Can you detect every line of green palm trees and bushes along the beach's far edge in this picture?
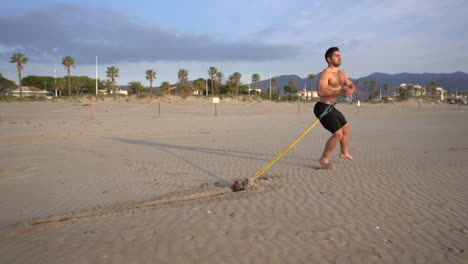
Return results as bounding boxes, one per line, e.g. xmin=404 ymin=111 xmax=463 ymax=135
xmin=10 ymin=53 xmax=446 ymax=101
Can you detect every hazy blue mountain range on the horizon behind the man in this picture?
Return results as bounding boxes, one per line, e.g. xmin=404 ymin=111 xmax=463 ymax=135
xmin=254 ymin=71 xmax=468 ymax=92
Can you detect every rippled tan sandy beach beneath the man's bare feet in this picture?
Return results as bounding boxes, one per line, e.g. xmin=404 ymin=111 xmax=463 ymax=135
xmin=0 ymin=97 xmax=468 ymax=263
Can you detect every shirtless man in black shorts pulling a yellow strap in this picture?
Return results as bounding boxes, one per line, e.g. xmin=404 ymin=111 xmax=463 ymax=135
xmin=314 ymin=47 xmax=356 ymax=166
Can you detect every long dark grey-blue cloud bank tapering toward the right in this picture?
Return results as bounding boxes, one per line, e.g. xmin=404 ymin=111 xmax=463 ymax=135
xmin=0 ymin=4 xmax=296 ymax=63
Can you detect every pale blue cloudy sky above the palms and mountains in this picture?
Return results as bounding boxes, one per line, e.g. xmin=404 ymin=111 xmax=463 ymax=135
xmin=0 ymin=0 xmax=468 ymax=85
